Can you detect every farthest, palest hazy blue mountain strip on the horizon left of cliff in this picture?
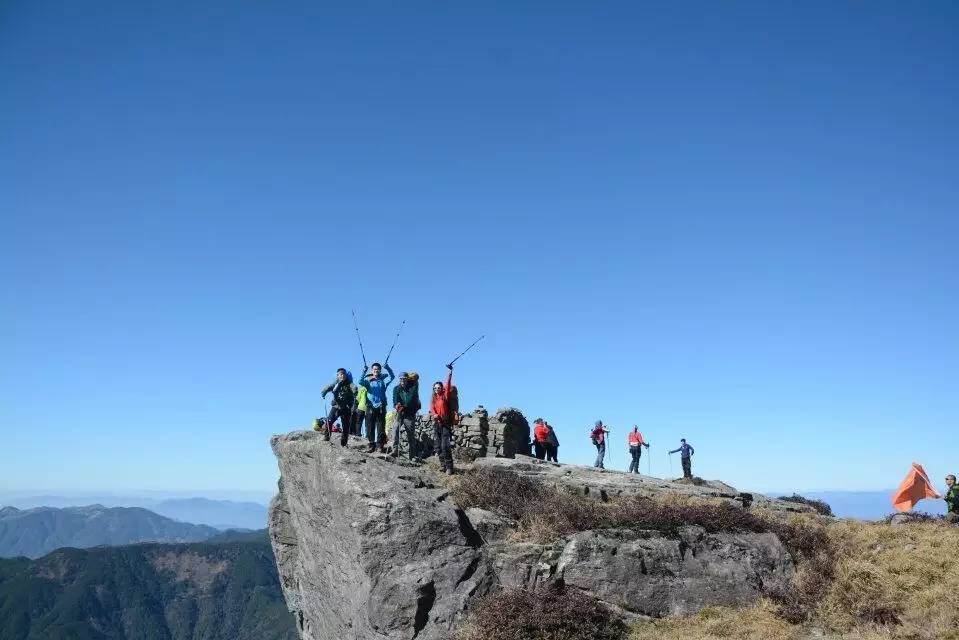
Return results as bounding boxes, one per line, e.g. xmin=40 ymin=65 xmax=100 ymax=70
xmin=0 ymin=494 xmax=267 ymax=529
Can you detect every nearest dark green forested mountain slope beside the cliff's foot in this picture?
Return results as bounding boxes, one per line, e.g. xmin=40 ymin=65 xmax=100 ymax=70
xmin=0 ymin=531 xmax=298 ymax=640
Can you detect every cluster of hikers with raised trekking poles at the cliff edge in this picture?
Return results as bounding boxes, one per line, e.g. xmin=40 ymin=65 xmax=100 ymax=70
xmin=314 ymin=362 xmax=459 ymax=475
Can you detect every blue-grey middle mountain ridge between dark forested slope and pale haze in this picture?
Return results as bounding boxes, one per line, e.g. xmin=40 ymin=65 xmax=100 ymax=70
xmin=0 ymin=505 xmax=220 ymax=558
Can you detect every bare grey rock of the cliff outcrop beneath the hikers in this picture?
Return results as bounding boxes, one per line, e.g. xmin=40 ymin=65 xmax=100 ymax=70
xmin=270 ymin=432 xmax=793 ymax=640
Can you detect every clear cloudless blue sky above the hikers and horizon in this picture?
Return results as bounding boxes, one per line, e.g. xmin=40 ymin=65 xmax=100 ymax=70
xmin=0 ymin=0 xmax=959 ymax=491
